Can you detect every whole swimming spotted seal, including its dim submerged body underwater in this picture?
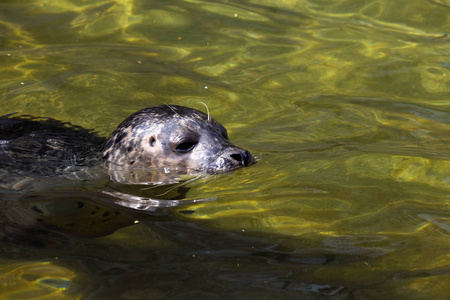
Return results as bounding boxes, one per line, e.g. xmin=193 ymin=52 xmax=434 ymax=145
xmin=0 ymin=105 xmax=255 ymax=247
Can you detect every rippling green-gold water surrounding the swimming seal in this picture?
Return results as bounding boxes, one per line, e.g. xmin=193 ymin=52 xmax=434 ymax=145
xmin=0 ymin=0 xmax=450 ymax=299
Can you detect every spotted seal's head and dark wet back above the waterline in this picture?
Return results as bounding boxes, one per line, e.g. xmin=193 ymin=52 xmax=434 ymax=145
xmin=0 ymin=105 xmax=256 ymax=190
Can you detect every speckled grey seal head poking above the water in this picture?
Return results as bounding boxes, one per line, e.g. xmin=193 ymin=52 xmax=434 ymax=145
xmin=102 ymin=105 xmax=256 ymax=174
